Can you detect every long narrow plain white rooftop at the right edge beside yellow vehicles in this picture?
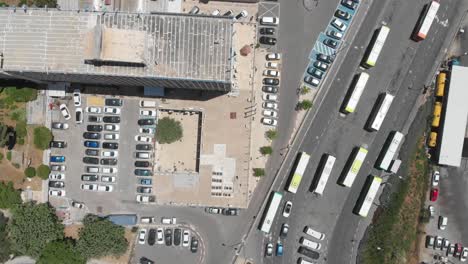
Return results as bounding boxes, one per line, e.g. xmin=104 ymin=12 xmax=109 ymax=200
xmin=439 ymin=66 xmax=468 ymax=167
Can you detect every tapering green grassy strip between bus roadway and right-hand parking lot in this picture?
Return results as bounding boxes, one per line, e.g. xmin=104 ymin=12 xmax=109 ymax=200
xmin=362 ymin=137 xmax=429 ymax=264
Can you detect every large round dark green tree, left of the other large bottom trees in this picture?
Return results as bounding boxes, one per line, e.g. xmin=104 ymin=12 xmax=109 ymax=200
xmin=8 ymin=203 xmax=63 ymax=258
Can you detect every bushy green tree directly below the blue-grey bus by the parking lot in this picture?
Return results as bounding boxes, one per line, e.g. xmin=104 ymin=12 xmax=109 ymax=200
xmin=76 ymin=215 xmax=128 ymax=259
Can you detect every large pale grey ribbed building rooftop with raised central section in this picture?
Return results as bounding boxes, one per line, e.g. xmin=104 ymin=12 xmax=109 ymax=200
xmin=0 ymin=9 xmax=232 ymax=82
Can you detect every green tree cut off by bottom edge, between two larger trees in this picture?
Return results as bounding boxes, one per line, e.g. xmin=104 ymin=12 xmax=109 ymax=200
xmin=37 ymin=239 xmax=86 ymax=264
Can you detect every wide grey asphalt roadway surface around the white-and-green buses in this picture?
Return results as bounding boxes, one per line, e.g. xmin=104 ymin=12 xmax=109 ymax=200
xmin=236 ymin=1 xmax=465 ymax=264
